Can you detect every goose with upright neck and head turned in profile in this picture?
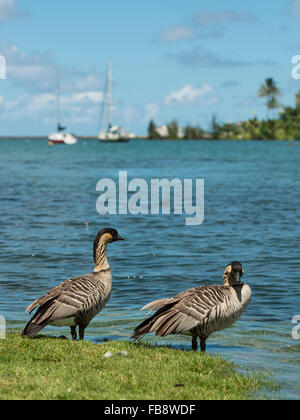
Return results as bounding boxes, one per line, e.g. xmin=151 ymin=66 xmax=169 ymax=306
xmin=22 ymin=228 xmax=123 ymax=340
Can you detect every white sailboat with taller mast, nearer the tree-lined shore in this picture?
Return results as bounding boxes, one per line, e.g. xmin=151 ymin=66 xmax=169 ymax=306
xmin=98 ymin=61 xmax=134 ymax=143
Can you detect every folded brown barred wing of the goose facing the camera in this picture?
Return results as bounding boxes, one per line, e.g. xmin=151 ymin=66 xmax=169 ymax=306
xmin=132 ymin=286 xmax=226 ymax=338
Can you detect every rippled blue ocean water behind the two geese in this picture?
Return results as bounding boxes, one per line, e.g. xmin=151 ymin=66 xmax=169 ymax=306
xmin=0 ymin=140 xmax=300 ymax=399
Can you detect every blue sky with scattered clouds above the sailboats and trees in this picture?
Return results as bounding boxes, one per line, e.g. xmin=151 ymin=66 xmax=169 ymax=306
xmin=0 ymin=0 xmax=300 ymax=136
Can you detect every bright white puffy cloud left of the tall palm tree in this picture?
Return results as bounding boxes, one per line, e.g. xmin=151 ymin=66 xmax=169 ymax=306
xmin=164 ymin=83 xmax=213 ymax=106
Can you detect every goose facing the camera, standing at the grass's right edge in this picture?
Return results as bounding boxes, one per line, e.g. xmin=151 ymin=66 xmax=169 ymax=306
xmin=132 ymin=261 xmax=251 ymax=352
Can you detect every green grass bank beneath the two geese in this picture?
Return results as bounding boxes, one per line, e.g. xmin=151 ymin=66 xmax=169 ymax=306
xmin=0 ymin=334 xmax=264 ymax=400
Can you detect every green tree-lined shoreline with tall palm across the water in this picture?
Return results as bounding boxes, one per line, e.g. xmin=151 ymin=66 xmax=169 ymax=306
xmin=148 ymin=78 xmax=300 ymax=140
